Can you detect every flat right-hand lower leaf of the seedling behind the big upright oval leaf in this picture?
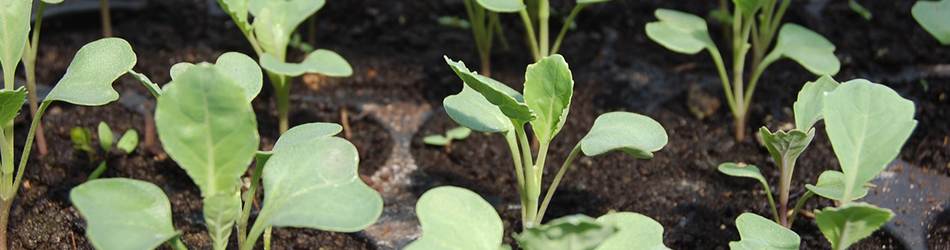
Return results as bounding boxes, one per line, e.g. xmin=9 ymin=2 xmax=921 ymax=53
xmin=261 ymin=49 xmax=353 ymax=77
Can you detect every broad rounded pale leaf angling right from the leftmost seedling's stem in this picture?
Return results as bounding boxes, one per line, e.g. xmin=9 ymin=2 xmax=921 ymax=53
xmin=44 ymin=38 xmax=138 ymax=106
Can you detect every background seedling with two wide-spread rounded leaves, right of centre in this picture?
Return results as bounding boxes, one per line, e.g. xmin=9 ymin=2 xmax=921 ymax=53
xmin=646 ymin=0 xmax=841 ymax=141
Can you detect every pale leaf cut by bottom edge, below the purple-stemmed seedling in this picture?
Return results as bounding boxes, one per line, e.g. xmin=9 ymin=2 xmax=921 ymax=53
xmin=729 ymin=213 xmax=801 ymax=250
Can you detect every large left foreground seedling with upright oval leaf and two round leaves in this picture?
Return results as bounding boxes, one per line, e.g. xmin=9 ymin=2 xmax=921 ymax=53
xmin=70 ymin=56 xmax=382 ymax=250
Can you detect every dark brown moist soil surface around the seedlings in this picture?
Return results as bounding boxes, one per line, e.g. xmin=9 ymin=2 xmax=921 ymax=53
xmin=9 ymin=0 xmax=950 ymax=249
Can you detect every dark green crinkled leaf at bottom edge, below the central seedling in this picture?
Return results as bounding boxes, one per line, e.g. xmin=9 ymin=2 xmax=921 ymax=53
xmin=515 ymin=214 xmax=617 ymax=250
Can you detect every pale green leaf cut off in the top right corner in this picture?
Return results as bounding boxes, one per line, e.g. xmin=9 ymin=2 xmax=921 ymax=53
xmin=910 ymin=0 xmax=950 ymax=45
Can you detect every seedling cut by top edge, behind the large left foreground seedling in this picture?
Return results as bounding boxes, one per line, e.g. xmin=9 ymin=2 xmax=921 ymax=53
xmin=217 ymin=0 xmax=353 ymax=134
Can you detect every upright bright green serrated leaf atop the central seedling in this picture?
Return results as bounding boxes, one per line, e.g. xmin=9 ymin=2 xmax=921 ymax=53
xmin=524 ymin=55 xmax=574 ymax=143
